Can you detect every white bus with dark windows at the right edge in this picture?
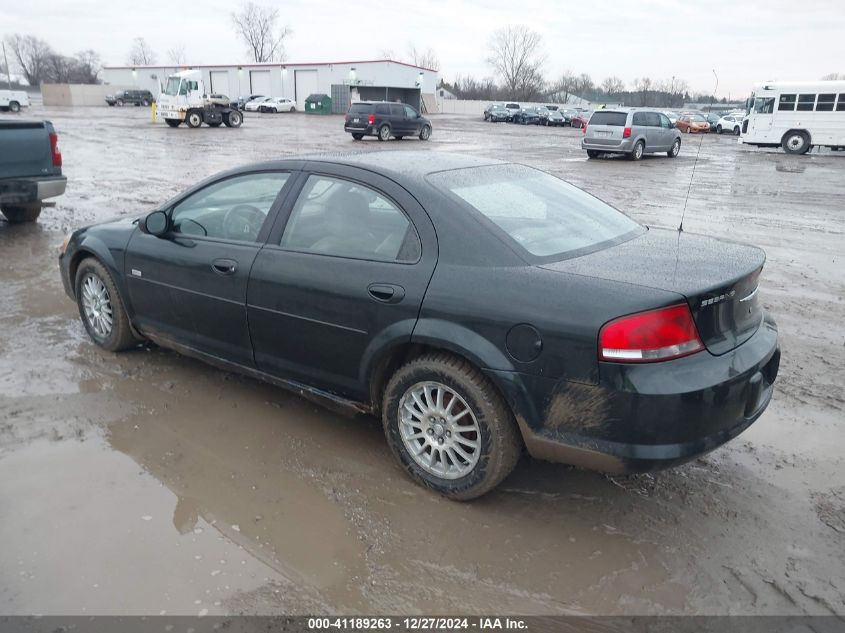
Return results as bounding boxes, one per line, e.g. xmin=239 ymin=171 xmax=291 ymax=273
xmin=739 ymin=81 xmax=845 ymax=154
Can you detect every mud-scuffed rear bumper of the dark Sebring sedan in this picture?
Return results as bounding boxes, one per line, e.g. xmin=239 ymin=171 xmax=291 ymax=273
xmin=487 ymin=319 xmax=780 ymax=473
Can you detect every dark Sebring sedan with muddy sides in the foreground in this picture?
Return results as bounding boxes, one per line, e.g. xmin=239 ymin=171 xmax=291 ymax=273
xmin=60 ymin=151 xmax=780 ymax=499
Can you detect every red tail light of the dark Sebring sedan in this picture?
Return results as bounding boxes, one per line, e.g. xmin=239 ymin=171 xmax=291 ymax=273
xmin=599 ymin=303 xmax=704 ymax=363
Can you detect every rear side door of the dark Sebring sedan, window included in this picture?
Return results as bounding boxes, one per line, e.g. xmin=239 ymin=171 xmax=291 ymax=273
xmin=247 ymin=163 xmax=437 ymax=400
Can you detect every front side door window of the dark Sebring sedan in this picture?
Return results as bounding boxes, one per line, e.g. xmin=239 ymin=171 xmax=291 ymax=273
xmin=171 ymin=172 xmax=290 ymax=242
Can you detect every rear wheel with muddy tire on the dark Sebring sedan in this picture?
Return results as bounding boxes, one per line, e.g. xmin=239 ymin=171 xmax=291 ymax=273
xmin=382 ymin=353 xmax=522 ymax=501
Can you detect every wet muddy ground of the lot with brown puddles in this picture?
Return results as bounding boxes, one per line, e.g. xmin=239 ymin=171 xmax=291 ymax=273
xmin=0 ymin=107 xmax=845 ymax=614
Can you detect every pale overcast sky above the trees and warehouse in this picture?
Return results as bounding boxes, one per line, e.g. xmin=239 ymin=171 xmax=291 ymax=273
xmin=0 ymin=0 xmax=845 ymax=97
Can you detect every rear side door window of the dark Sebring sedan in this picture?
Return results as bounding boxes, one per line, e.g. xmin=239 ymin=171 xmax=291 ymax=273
xmin=281 ymin=175 xmax=421 ymax=263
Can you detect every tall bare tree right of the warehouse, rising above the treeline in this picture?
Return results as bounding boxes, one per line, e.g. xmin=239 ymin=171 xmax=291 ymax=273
xmin=487 ymin=24 xmax=545 ymax=100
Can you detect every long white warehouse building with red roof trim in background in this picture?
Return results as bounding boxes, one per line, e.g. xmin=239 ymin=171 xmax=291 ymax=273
xmin=101 ymin=59 xmax=439 ymax=113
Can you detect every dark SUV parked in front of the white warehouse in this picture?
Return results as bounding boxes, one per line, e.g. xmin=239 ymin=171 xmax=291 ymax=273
xmin=343 ymin=101 xmax=431 ymax=141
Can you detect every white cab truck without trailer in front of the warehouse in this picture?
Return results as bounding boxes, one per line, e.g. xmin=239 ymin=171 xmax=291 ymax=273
xmin=156 ymin=70 xmax=244 ymax=127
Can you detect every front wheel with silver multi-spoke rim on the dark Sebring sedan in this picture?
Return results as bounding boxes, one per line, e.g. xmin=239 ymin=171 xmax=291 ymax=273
xmin=74 ymin=257 xmax=141 ymax=352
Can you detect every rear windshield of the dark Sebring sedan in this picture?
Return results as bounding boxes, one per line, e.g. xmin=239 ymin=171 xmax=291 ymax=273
xmin=428 ymin=165 xmax=646 ymax=262
